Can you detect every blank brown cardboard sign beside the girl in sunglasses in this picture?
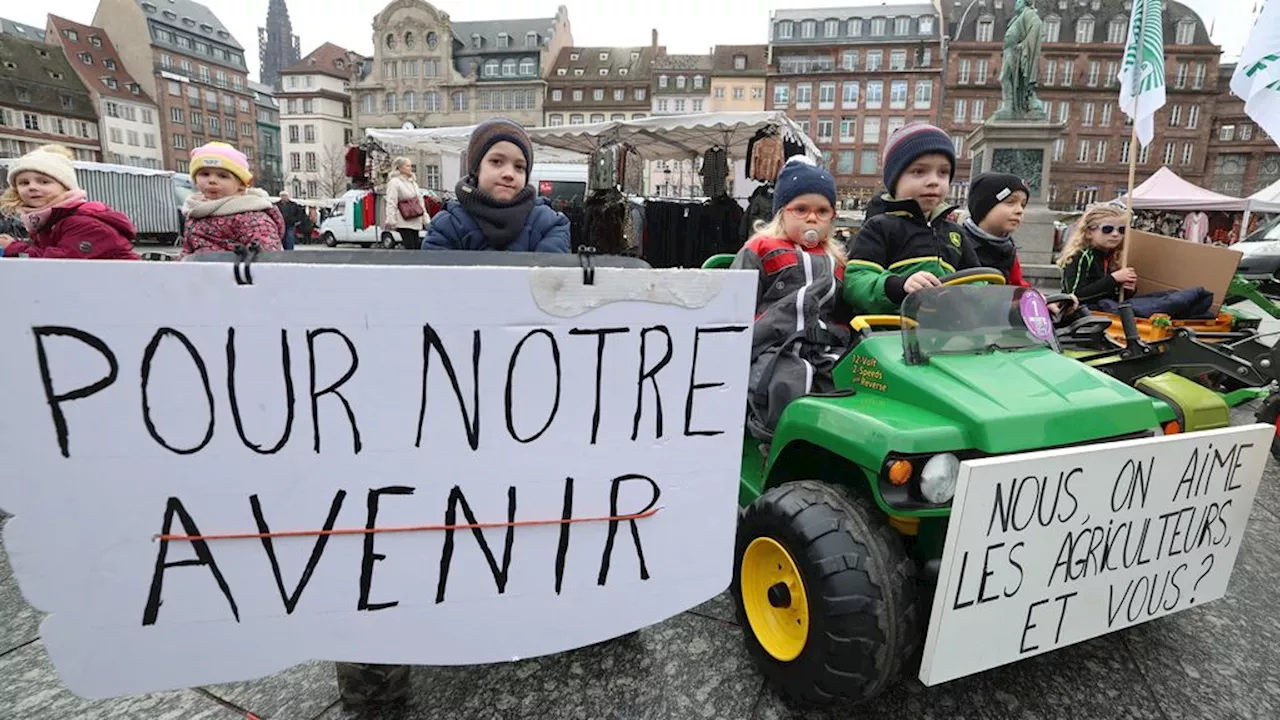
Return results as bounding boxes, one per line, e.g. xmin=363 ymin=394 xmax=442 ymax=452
xmin=1129 ymin=229 xmax=1243 ymax=313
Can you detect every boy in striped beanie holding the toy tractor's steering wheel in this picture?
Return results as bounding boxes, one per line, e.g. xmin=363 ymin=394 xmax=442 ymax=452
xmin=846 ymin=123 xmax=979 ymax=313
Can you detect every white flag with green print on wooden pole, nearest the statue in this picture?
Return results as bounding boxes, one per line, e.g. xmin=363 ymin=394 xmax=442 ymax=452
xmin=1119 ymin=0 xmax=1165 ymax=147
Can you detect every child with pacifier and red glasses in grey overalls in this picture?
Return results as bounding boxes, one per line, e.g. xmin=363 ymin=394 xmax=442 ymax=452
xmin=732 ymin=156 xmax=852 ymax=442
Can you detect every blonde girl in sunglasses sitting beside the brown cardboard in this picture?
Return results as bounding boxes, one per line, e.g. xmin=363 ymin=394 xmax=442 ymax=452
xmin=1057 ymin=205 xmax=1138 ymax=306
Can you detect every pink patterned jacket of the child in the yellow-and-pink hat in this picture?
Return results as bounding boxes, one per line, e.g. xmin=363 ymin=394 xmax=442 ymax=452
xmin=182 ymin=187 xmax=284 ymax=258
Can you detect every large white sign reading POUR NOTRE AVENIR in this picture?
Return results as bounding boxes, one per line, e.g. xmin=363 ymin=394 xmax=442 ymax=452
xmin=0 ymin=260 xmax=756 ymax=698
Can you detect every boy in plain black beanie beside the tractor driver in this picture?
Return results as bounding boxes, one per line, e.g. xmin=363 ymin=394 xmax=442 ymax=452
xmin=961 ymin=173 xmax=1032 ymax=287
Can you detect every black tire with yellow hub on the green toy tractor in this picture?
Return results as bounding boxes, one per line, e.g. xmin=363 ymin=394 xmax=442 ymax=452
xmin=732 ymin=480 xmax=919 ymax=706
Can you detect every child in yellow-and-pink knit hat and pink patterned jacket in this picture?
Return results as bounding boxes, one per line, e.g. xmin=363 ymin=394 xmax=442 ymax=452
xmin=182 ymin=142 xmax=284 ymax=258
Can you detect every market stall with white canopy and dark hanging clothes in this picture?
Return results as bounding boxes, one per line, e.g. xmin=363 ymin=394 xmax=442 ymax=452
xmin=366 ymin=111 xmax=822 ymax=268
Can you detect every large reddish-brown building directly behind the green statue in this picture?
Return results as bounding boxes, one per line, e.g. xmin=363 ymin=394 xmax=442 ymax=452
xmin=941 ymin=0 xmax=1222 ymax=209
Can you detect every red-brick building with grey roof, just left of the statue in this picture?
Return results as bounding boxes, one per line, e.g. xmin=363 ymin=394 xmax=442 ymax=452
xmin=765 ymin=3 xmax=942 ymax=200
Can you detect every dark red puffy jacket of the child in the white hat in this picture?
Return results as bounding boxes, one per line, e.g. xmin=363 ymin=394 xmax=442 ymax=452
xmin=0 ymin=201 xmax=140 ymax=260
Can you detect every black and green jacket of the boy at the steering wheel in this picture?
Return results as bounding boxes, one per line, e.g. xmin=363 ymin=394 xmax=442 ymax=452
xmin=845 ymin=195 xmax=979 ymax=314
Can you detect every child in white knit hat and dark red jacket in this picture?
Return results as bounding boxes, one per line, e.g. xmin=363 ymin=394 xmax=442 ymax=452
xmin=0 ymin=145 xmax=138 ymax=260
